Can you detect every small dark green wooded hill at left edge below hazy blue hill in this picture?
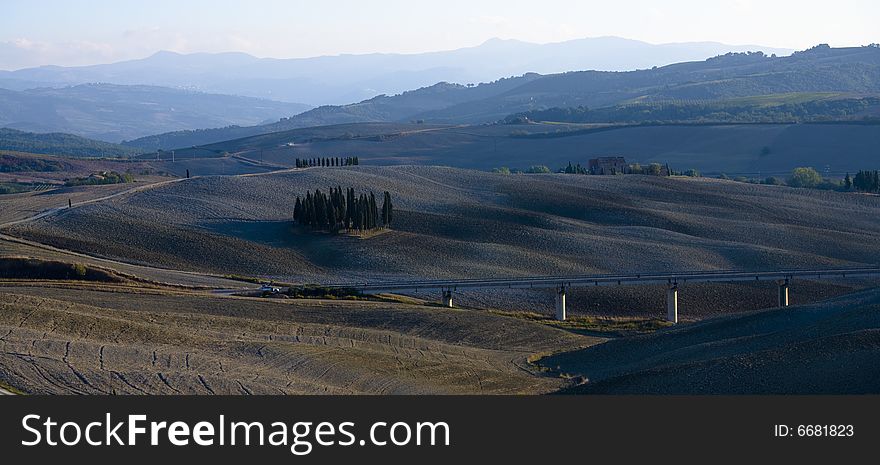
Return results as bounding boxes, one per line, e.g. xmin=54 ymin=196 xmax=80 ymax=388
xmin=0 ymin=128 xmax=141 ymax=158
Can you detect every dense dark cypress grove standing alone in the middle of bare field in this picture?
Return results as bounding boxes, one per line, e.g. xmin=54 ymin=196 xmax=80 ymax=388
xmin=293 ymin=187 xmax=394 ymax=233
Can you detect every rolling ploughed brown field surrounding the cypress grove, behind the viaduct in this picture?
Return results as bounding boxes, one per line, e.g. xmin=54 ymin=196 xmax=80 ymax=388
xmin=4 ymin=166 xmax=880 ymax=319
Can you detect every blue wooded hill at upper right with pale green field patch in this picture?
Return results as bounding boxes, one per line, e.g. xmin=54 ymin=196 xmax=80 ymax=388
xmin=417 ymin=46 xmax=880 ymax=123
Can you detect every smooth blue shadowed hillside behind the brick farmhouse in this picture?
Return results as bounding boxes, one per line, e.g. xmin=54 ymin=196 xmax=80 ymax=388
xmin=155 ymin=123 xmax=880 ymax=177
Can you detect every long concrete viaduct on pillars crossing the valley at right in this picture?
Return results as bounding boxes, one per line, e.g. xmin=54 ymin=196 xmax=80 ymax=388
xmin=324 ymin=266 xmax=880 ymax=323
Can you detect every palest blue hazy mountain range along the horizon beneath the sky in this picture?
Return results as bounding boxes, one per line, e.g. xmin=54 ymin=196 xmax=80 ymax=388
xmin=0 ymin=37 xmax=792 ymax=106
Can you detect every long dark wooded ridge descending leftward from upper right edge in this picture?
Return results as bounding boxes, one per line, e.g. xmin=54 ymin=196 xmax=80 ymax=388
xmin=127 ymin=45 xmax=880 ymax=150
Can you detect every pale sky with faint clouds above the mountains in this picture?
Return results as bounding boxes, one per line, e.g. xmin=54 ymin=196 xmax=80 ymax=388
xmin=0 ymin=0 xmax=880 ymax=70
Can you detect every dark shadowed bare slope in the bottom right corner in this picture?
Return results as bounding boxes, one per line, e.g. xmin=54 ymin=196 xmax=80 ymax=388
xmin=539 ymin=289 xmax=880 ymax=394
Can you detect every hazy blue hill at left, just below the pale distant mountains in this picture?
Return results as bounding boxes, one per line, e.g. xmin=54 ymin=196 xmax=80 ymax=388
xmin=0 ymin=84 xmax=309 ymax=142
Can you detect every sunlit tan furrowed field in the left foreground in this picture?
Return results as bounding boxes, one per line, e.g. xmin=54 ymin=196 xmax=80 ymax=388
xmin=0 ymin=283 xmax=601 ymax=394
